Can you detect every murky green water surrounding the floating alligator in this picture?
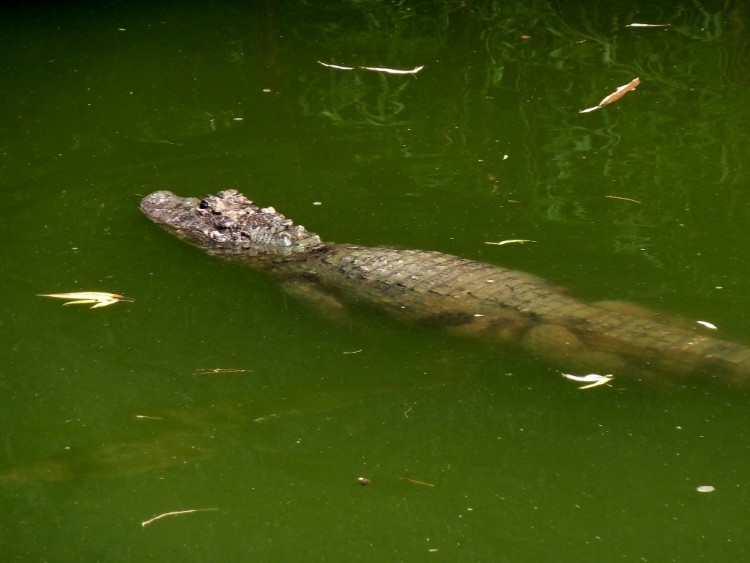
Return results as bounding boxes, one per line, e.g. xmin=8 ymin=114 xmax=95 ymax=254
xmin=0 ymin=0 xmax=750 ymax=561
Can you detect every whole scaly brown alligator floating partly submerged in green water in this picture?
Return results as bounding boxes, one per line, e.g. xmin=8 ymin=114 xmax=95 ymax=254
xmin=140 ymin=189 xmax=750 ymax=387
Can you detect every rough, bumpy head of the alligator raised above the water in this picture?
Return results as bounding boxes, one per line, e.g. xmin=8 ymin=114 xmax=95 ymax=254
xmin=141 ymin=190 xmax=323 ymax=256
